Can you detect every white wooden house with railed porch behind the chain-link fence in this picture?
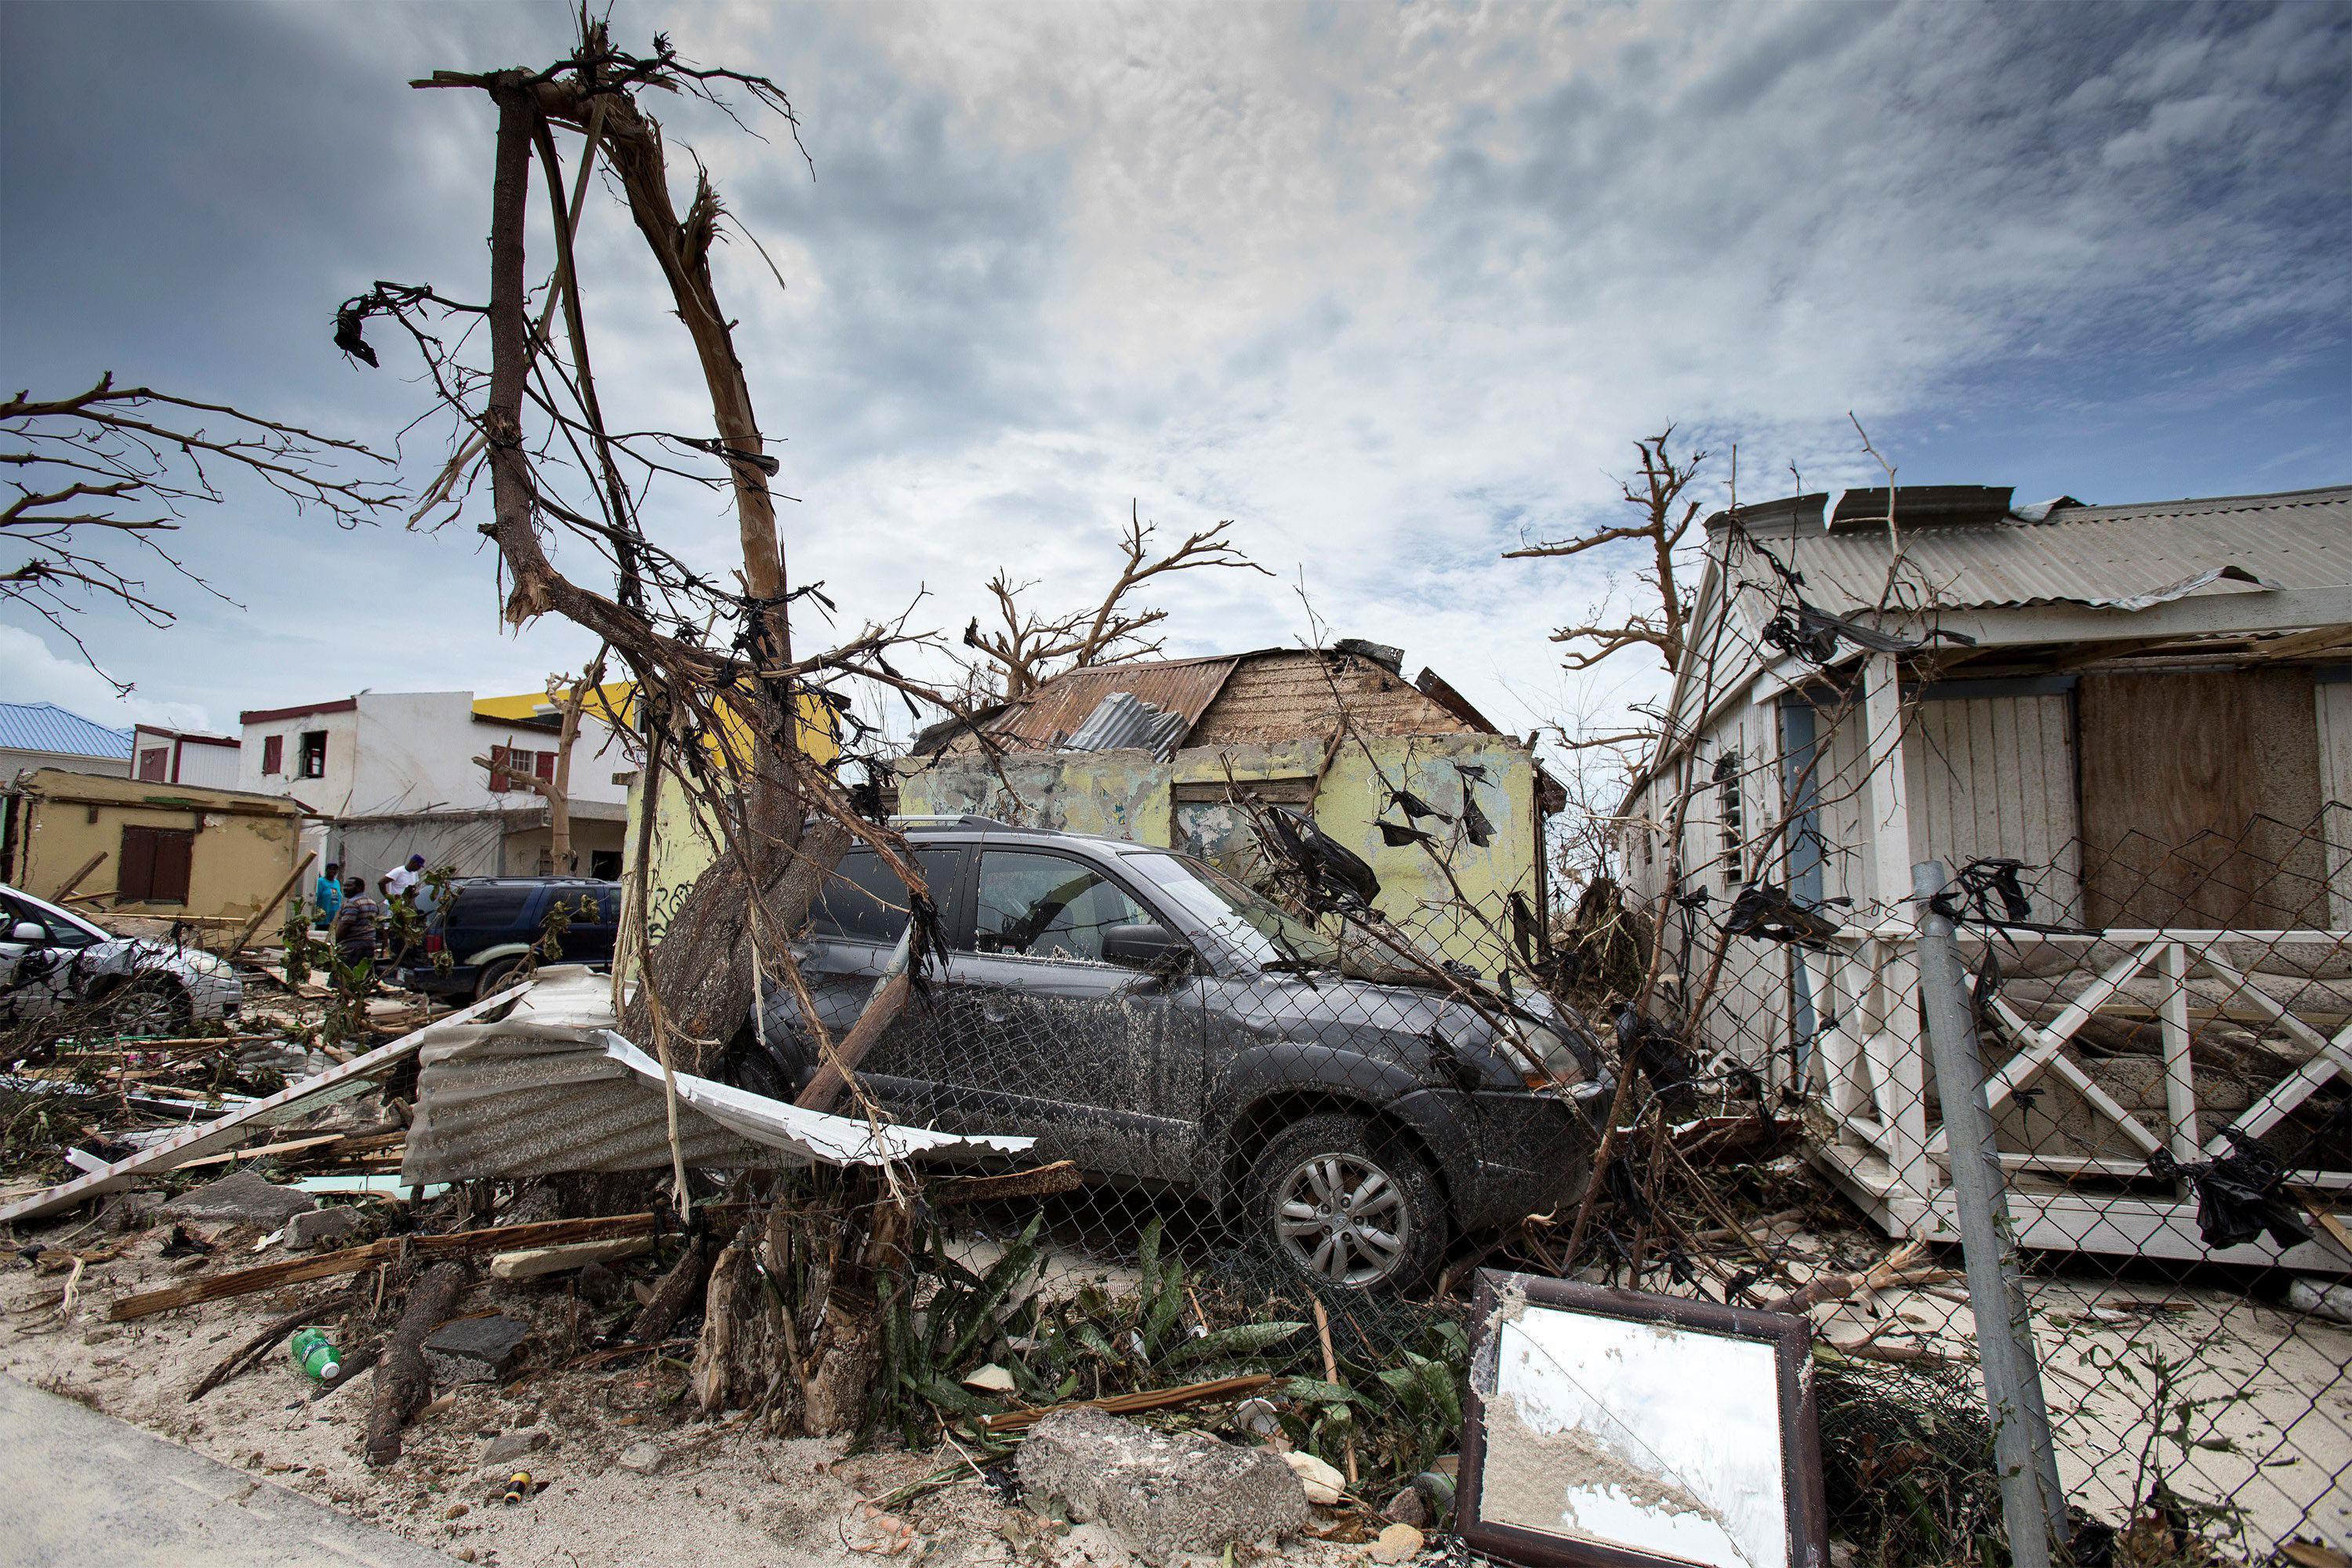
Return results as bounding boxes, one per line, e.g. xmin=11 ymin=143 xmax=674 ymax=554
xmin=1621 ymin=487 xmax=2352 ymax=1267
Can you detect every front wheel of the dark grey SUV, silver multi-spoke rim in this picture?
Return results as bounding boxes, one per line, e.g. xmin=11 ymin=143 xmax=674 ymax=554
xmin=1251 ymin=1114 xmax=1446 ymax=1293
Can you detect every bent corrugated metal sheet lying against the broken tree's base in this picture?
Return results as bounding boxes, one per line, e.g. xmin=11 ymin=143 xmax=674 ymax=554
xmin=400 ymin=964 xmax=1033 ymax=1182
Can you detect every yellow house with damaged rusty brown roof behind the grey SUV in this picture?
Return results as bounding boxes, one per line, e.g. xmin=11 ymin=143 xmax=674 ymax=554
xmin=898 ymin=640 xmax=1564 ymax=973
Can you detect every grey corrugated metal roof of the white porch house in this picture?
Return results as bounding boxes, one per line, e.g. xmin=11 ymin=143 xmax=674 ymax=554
xmin=1738 ymin=487 xmax=2352 ymax=614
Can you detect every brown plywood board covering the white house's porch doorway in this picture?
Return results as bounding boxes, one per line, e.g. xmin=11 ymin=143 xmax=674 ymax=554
xmin=2074 ymin=670 xmax=2326 ymax=928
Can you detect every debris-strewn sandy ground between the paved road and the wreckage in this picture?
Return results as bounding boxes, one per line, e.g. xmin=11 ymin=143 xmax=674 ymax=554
xmin=0 ymin=1227 xmax=1364 ymax=1568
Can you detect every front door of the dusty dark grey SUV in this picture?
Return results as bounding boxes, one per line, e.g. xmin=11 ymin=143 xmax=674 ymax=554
xmin=941 ymin=841 xmax=1202 ymax=1182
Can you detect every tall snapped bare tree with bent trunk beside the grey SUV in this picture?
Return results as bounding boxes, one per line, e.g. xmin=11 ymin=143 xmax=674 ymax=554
xmin=336 ymin=21 xmax=964 ymax=1105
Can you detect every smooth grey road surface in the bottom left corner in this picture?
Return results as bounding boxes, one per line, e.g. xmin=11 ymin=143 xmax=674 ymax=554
xmin=0 ymin=1375 xmax=452 ymax=1568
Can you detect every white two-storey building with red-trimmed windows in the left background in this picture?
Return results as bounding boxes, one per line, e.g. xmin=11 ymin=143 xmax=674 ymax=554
xmin=238 ymin=691 xmax=630 ymax=881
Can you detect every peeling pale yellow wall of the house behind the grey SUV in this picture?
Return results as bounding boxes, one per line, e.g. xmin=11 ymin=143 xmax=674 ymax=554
xmin=898 ymin=734 xmax=1543 ymax=973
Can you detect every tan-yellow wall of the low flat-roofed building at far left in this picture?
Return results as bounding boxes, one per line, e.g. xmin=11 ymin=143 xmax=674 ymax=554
xmin=9 ymin=769 xmax=308 ymax=921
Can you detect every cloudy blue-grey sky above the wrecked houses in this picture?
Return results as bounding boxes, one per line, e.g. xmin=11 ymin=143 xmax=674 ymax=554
xmin=0 ymin=0 xmax=2352 ymax=747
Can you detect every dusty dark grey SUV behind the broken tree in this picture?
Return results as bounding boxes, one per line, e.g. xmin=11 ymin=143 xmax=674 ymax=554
xmin=734 ymin=818 xmax=1609 ymax=1290
